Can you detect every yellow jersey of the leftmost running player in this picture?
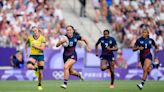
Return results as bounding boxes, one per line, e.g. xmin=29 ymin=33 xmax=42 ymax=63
xmin=28 ymin=35 xmax=45 ymax=55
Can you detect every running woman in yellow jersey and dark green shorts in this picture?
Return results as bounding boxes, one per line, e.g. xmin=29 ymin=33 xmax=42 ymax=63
xmin=25 ymin=27 xmax=46 ymax=90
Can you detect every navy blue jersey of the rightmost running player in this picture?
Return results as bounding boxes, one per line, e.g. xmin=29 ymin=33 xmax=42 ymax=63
xmin=135 ymin=37 xmax=155 ymax=59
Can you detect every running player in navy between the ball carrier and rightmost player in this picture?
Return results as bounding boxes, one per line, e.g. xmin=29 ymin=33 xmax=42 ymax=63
xmin=95 ymin=30 xmax=118 ymax=88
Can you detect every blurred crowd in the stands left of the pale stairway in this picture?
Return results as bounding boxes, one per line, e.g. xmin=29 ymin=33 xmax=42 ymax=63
xmin=0 ymin=0 xmax=66 ymax=50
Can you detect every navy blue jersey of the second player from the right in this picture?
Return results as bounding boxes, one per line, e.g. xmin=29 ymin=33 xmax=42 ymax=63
xmin=96 ymin=37 xmax=117 ymax=56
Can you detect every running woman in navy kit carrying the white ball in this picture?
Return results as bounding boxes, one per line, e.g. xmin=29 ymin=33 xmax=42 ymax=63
xmin=56 ymin=25 xmax=90 ymax=89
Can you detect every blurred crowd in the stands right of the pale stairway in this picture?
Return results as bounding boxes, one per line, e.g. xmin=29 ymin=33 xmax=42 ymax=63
xmin=107 ymin=0 xmax=164 ymax=50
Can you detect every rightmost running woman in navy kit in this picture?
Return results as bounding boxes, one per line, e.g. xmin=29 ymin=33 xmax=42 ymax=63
xmin=133 ymin=29 xmax=158 ymax=90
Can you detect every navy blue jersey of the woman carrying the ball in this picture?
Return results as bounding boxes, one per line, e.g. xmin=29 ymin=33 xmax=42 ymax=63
xmin=63 ymin=35 xmax=81 ymax=57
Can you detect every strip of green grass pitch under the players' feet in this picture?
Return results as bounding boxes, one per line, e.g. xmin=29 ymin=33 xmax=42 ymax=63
xmin=0 ymin=81 xmax=164 ymax=92
